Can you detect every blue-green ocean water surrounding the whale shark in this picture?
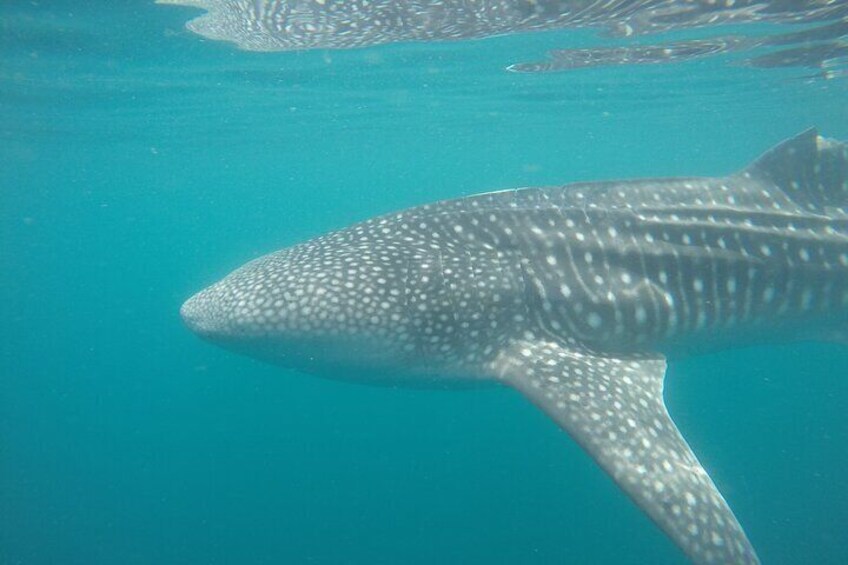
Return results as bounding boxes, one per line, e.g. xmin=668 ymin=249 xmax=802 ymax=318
xmin=0 ymin=1 xmax=848 ymax=565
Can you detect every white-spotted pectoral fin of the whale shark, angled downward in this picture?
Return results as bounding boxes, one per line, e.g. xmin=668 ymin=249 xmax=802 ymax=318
xmin=489 ymin=341 xmax=759 ymax=563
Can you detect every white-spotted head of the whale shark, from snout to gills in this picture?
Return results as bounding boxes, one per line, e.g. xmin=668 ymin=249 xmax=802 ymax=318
xmin=180 ymin=206 xmax=527 ymax=388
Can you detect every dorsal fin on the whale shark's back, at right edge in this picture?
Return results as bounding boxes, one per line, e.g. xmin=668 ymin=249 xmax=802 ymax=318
xmin=743 ymin=128 xmax=848 ymax=209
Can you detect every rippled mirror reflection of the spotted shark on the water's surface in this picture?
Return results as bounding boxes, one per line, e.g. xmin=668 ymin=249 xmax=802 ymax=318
xmin=161 ymin=0 xmax=848 ymax=77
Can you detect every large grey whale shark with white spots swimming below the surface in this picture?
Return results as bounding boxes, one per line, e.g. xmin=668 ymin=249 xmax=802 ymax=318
xmin=181 ymin=129 xmax=848 ymax=563
